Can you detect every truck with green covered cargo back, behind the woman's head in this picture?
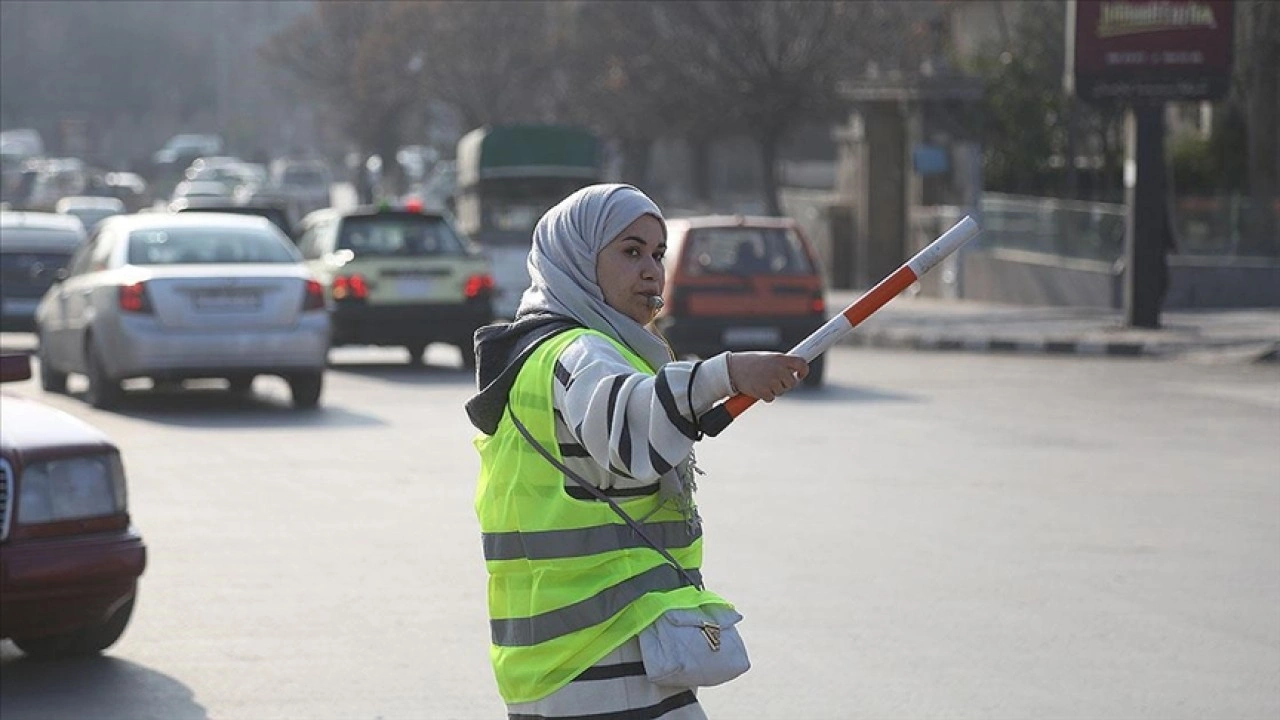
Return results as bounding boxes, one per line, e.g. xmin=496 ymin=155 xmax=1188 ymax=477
xmin=454 ymin=124 xmax=602 ymax=318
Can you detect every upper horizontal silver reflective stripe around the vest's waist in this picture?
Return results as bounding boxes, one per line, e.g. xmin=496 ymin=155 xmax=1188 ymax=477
xmin=484 ymin=520 xmax=703 ymax=560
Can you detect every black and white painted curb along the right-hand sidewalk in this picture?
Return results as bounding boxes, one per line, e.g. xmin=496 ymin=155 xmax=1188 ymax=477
xmin=844 ymin=329 xmax=1280 ymax=363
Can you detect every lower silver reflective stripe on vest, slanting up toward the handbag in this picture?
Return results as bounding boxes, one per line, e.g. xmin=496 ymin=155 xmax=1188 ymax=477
xmin=489 ymin=564 xmax=703 ymax=647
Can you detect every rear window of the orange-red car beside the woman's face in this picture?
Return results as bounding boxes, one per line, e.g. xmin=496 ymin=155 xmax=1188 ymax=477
xmin=685 ymin=228 xmax=813 ymax=275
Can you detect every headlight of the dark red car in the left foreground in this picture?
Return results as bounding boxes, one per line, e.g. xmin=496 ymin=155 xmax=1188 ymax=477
xmin=17 ymin=454 xmax=128 ymax=525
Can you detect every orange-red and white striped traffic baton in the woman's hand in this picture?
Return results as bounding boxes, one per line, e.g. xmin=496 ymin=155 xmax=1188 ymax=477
xmin=699 ymin=215 xmax=978 ymax=437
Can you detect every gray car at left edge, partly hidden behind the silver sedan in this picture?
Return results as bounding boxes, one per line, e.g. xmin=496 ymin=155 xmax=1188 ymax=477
xmin=0 ymin=211 xmax=84 ymax=332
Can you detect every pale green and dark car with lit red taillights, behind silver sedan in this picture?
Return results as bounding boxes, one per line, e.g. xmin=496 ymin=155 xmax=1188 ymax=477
xmin=298 ymin=208 xmax=494 ymax=368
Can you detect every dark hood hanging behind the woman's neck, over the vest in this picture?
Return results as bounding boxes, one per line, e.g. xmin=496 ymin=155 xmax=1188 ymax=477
xmin=466 ymin=313 xmax=582 ymax=436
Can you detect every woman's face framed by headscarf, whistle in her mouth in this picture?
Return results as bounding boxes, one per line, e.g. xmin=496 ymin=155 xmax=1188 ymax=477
xmin=595 ymin=215 xmax=667 ymax=325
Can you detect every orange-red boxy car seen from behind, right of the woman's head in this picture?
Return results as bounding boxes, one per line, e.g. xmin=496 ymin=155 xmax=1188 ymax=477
xmin=657 ymin=215 xmax=827 ymax=387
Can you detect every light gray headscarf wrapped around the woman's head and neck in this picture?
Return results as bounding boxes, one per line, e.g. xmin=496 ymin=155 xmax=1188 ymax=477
xmin=516 ymin=184 xmax=671 ymax=369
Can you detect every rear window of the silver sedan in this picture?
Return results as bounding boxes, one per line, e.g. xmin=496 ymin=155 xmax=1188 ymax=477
xmin=129 ymin=227 xmax=300 ymax=265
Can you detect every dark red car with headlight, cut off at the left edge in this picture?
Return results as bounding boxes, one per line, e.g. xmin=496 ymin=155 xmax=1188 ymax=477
xmin=0 ymin=355 xmax=147 ymax=657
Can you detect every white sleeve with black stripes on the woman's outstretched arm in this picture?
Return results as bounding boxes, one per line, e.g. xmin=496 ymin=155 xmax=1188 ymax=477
xmin=553 ymin=334 xmax=731 ymax=489
